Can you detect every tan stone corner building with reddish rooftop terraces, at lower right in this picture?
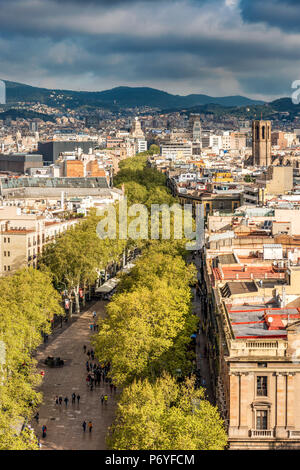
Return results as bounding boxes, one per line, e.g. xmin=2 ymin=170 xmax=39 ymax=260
xmin=205 ymin=255 xmax=300 ymax=450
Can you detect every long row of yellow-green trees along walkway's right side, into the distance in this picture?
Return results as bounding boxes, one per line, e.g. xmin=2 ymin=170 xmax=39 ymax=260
xmin=94 ymin=157 xmax=227 ymax=450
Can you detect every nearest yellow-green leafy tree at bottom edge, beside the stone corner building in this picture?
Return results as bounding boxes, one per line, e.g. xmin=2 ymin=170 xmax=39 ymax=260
xmin=107 ymin=375 xmax=227 ymax=450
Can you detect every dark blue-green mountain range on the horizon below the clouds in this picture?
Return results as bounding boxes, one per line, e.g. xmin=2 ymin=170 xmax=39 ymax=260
xmin=3 ymin=80 xmax=263 ymax=110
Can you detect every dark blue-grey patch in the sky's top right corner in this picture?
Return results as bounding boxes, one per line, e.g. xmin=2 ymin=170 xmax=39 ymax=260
xmin=240 ymin=0 xmax=300 ymax=32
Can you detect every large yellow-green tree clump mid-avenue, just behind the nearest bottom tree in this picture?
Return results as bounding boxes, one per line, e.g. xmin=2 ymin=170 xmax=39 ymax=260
xmin=95 ymin=243 xmax=197 ymax=386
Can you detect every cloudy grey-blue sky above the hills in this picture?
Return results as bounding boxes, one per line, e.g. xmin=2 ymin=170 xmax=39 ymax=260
xmin=0 ymin=0 xmax=300 ymax=100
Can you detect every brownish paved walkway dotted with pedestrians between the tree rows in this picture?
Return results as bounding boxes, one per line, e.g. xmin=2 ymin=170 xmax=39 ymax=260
xmin=32 ymin=301 xmax=117 ymax=450
